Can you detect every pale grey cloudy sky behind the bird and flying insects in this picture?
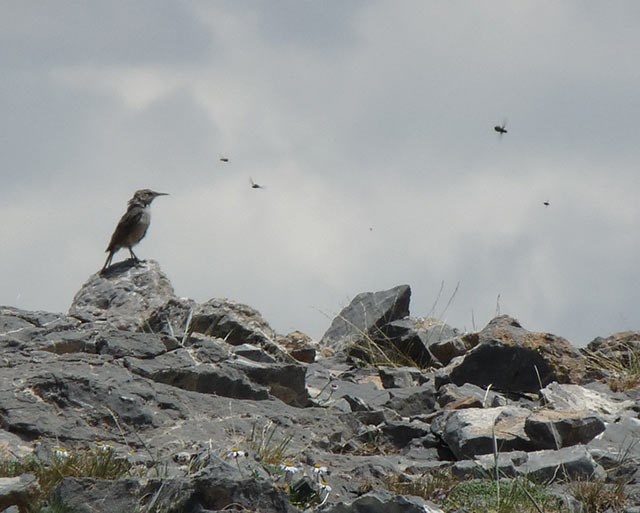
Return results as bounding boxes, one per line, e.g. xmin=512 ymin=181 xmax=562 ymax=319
xmin=0 ymin=0 xmax=640 ymax=345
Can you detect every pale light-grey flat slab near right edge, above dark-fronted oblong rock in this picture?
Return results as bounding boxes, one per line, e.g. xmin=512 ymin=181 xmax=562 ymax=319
xmin=540 ymin=383 xmax=635 ymax=422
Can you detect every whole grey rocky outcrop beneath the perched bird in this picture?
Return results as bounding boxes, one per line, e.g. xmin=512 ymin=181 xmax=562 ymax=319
xmin=0 ymin=272 xmax=640 ymax=513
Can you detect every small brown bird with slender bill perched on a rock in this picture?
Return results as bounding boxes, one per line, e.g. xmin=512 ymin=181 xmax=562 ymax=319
xmin=100 ymin=189 xmax=168 ymax=273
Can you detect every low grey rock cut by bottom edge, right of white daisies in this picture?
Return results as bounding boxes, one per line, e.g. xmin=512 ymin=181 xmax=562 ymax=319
xmin=323 ymin=490 xmax=443 ymax=513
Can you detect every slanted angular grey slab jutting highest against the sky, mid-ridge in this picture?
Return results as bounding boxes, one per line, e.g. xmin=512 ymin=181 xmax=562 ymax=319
xmin=320 ymin=285 xmax=411 ymax=351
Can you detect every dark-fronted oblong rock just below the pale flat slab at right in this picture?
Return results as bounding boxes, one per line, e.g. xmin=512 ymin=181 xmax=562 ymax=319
xmin=524 ymin=409 xmax=605 ymax=449
